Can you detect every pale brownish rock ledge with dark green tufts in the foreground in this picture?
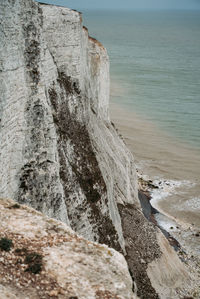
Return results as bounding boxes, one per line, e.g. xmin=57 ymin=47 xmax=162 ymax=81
xmin=0 ymin=199 xmax=137 ymax=299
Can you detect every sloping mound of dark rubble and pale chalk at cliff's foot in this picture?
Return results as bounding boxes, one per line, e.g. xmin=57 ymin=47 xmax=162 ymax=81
xmin=119 ymin=205 xmax=191 ymax=299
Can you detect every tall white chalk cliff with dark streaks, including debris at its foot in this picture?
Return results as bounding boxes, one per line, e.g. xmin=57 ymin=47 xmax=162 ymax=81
xmin=0 ymin=0 xmax=194 ymax=299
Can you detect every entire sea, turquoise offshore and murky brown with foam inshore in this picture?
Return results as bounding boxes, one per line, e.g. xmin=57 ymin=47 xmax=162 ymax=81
xmin=83 ymin=10 xmax=200 ymax=253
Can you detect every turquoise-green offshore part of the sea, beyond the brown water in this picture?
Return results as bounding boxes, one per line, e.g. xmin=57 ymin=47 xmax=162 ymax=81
xmin=83 ymin=11 xmax=200 ymax=148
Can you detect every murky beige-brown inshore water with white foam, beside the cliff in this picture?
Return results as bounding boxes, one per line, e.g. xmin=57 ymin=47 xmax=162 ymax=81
xmin=110 ymin=103 xmax=200 ymax=255
